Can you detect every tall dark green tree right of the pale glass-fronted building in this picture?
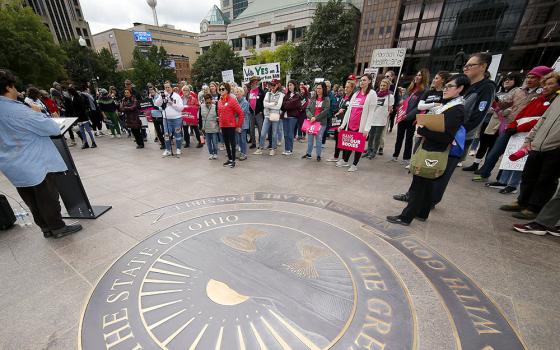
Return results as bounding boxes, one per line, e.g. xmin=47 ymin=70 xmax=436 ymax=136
xmin=297 ymin=0 xmax=360 ymax=82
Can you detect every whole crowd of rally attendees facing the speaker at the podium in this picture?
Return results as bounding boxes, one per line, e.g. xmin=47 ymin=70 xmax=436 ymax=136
xmin=0 ymin=53 xmax=560 ymax=236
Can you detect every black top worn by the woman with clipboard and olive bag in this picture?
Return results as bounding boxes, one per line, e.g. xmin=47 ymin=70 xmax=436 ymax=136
xmin=418 ymin=100 xmax=465 ymax=152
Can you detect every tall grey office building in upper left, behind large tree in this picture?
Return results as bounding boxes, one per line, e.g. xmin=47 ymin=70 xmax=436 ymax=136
xmin=26 ymin=0 xmax=93 ymax=48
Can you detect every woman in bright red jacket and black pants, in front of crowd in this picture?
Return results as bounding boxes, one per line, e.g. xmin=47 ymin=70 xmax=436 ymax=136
xmin=218 ymin=83 xmax=245 ymax=168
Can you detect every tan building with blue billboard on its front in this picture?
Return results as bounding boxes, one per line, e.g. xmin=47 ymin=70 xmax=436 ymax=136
xmin=93 ymin=23 xmax=199 ymax=80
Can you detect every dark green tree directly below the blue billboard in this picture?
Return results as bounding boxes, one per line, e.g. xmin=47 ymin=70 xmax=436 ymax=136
xmin=132 ymin=46 xmax=176 ymax=89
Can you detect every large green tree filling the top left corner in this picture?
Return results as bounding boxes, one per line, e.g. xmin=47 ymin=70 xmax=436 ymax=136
xmin=0 ymin=0 xmax=66 ymax=88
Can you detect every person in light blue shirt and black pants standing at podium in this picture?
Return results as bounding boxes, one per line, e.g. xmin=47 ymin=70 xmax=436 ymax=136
xmin=0 ymin=69 xmax=82 ymax=238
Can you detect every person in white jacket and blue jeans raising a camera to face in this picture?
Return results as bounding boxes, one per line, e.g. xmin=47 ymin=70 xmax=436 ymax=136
xmin=155 ymin=80 xmax=183 ymax=157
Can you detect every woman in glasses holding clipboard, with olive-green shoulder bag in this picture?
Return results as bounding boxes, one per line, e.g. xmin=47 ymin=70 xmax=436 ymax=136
xmin=387 ymin=74 xmax=470 ymax=226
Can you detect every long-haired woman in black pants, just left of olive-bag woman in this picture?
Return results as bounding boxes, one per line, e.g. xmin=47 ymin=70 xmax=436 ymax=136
xmin=391 ymin=68 xmax=430 ymax=165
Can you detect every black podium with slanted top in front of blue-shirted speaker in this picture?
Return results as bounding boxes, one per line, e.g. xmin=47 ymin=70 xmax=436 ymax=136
xmin=51 ymin=118 xmax=112 ymax=219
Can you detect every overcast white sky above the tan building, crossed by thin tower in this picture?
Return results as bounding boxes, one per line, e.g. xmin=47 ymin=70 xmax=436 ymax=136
xmin=80 ymin=0 xmax=220 ymax=34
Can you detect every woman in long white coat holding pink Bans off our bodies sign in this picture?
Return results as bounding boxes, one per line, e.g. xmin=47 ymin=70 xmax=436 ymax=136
xmin=336 ymin=74 xmax=377 ymax=172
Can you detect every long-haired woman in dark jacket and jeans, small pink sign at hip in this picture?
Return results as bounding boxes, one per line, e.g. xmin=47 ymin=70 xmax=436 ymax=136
xmin=301 ymin=82 xmax=331 ymax=162
